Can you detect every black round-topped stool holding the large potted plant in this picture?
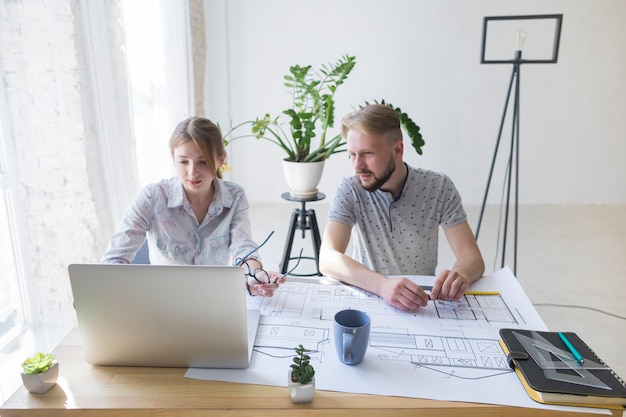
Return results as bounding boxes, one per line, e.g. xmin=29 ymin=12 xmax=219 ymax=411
xmin=280 ymin=192 xmax=326 ymax=277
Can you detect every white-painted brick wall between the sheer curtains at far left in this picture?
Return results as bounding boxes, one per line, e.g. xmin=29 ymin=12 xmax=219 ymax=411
xmin=0 ymin=0 xmax=103 ymax=325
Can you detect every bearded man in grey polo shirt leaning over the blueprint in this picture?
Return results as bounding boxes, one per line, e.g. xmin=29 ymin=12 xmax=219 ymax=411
xmin=320 ymin=104 xmax=484 ymax=311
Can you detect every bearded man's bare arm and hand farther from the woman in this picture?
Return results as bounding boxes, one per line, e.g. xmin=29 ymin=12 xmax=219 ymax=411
xmin=431 ymin=221 xmax=485 ymax=300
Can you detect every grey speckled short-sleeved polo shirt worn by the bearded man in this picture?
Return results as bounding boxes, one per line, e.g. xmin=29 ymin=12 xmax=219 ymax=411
xmin=328 ymin=166 xmax=467 ymax=275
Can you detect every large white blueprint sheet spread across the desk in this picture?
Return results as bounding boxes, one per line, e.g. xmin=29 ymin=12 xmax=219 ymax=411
xmin=186 ymin=268 xmax=604 ymax=410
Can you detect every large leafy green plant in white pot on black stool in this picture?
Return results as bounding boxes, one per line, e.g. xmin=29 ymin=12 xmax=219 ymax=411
xmin=223 ymin=54 xmax=424 ymax=198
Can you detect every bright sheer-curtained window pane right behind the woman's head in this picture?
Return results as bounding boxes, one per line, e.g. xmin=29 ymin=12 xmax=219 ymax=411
xmin=122 ymin=0 xmax=193 ymax=185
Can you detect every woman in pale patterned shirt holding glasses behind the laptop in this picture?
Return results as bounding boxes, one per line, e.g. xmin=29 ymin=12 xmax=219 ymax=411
xmin=102 ymin=117 xmax=284 ymax=297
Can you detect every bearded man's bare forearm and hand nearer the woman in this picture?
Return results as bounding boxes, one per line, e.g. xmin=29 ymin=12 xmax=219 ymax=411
xmin=320 ymin=221 xmax=429 ymax=311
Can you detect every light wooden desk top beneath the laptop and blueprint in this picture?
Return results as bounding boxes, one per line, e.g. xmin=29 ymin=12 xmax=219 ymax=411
xmin=0 ymin=330 xmax=622 ymax=417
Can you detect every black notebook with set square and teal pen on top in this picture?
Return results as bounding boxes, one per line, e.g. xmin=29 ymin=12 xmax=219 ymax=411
xmin=500 ymin=329 xmax=626 ymax=408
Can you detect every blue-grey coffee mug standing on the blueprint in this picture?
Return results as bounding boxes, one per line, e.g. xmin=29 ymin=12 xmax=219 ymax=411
xmin=334 ymin=310 xmax=371 ymax=365
